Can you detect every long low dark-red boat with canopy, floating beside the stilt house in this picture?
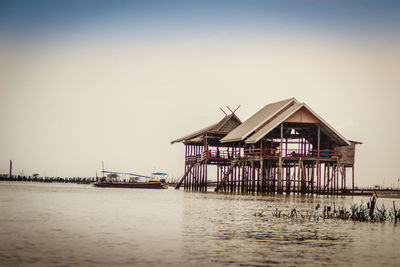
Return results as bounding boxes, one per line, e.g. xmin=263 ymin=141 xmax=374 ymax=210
xmin=94 ymin=171 xmax=168 ymax=189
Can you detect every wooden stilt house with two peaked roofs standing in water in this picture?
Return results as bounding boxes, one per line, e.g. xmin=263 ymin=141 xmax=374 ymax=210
xmin=171 ymin=98 xmax=361 ymax=194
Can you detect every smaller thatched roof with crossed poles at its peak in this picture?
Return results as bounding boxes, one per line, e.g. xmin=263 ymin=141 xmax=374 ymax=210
xmin=171 ymin=114 xmax=242 ymax=144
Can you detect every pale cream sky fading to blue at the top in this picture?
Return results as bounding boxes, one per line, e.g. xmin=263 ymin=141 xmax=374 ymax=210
xmin=0 ymin=0 xmax=400 ymax=186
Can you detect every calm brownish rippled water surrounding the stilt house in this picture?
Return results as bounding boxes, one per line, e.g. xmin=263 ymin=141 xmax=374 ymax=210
xmin=0 ymin=182 xmax=400 ymax=266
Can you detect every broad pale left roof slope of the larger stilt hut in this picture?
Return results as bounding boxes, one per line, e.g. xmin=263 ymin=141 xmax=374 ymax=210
xmin=221 ymin=97 xmax=299 ymax=143
